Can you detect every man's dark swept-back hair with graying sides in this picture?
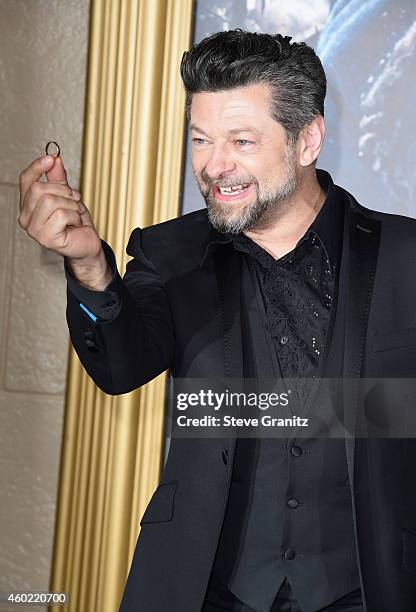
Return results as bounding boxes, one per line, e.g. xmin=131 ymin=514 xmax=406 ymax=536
xmin=181 ymin=28 xmax=326 ymax=142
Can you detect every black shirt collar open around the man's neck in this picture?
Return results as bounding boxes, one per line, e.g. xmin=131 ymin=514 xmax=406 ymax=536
xmin=200 ymin=169 xmax=343 ymax=266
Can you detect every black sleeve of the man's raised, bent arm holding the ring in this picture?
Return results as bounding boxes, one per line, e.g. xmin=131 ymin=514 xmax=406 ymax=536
xmin=65 ymin=228 xmax=174 ymax=395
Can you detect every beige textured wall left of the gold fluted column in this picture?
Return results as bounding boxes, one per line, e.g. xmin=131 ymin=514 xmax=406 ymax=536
xmin=0 ymin=0 xmax=89 ymax=610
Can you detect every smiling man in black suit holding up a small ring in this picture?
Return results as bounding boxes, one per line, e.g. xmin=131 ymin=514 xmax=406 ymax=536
xmin=19 ymin=30 xmax=416 ymax=612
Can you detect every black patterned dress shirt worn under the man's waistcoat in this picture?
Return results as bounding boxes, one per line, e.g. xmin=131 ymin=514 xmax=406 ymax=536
xmin=233 ymin=184 xmax=342 ymax=378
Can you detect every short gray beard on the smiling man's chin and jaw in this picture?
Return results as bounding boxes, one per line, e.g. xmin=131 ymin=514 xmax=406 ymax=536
xmin=198 ymin=147 xmax=298 ymax=234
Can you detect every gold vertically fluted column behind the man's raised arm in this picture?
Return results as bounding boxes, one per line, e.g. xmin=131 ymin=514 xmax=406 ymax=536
xmin=50 ymin=0 xmax=193 ymax=612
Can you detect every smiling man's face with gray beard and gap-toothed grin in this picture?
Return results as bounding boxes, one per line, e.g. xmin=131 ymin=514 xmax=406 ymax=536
xmin=191 ymin=84 xmax=297 ymax=233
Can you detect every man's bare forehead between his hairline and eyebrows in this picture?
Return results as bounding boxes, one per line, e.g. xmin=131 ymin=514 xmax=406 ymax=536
xmin=191 ymin=83 xmax=273 ymax=126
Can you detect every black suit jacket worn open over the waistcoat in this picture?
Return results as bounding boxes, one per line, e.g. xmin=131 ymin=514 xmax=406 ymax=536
xmin=67 ymin=175 xmax=416 ymax=612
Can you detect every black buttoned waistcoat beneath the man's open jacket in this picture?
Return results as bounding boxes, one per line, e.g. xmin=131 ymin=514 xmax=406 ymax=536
xmin=212 ymin=256 xmax=360 ymax=612
